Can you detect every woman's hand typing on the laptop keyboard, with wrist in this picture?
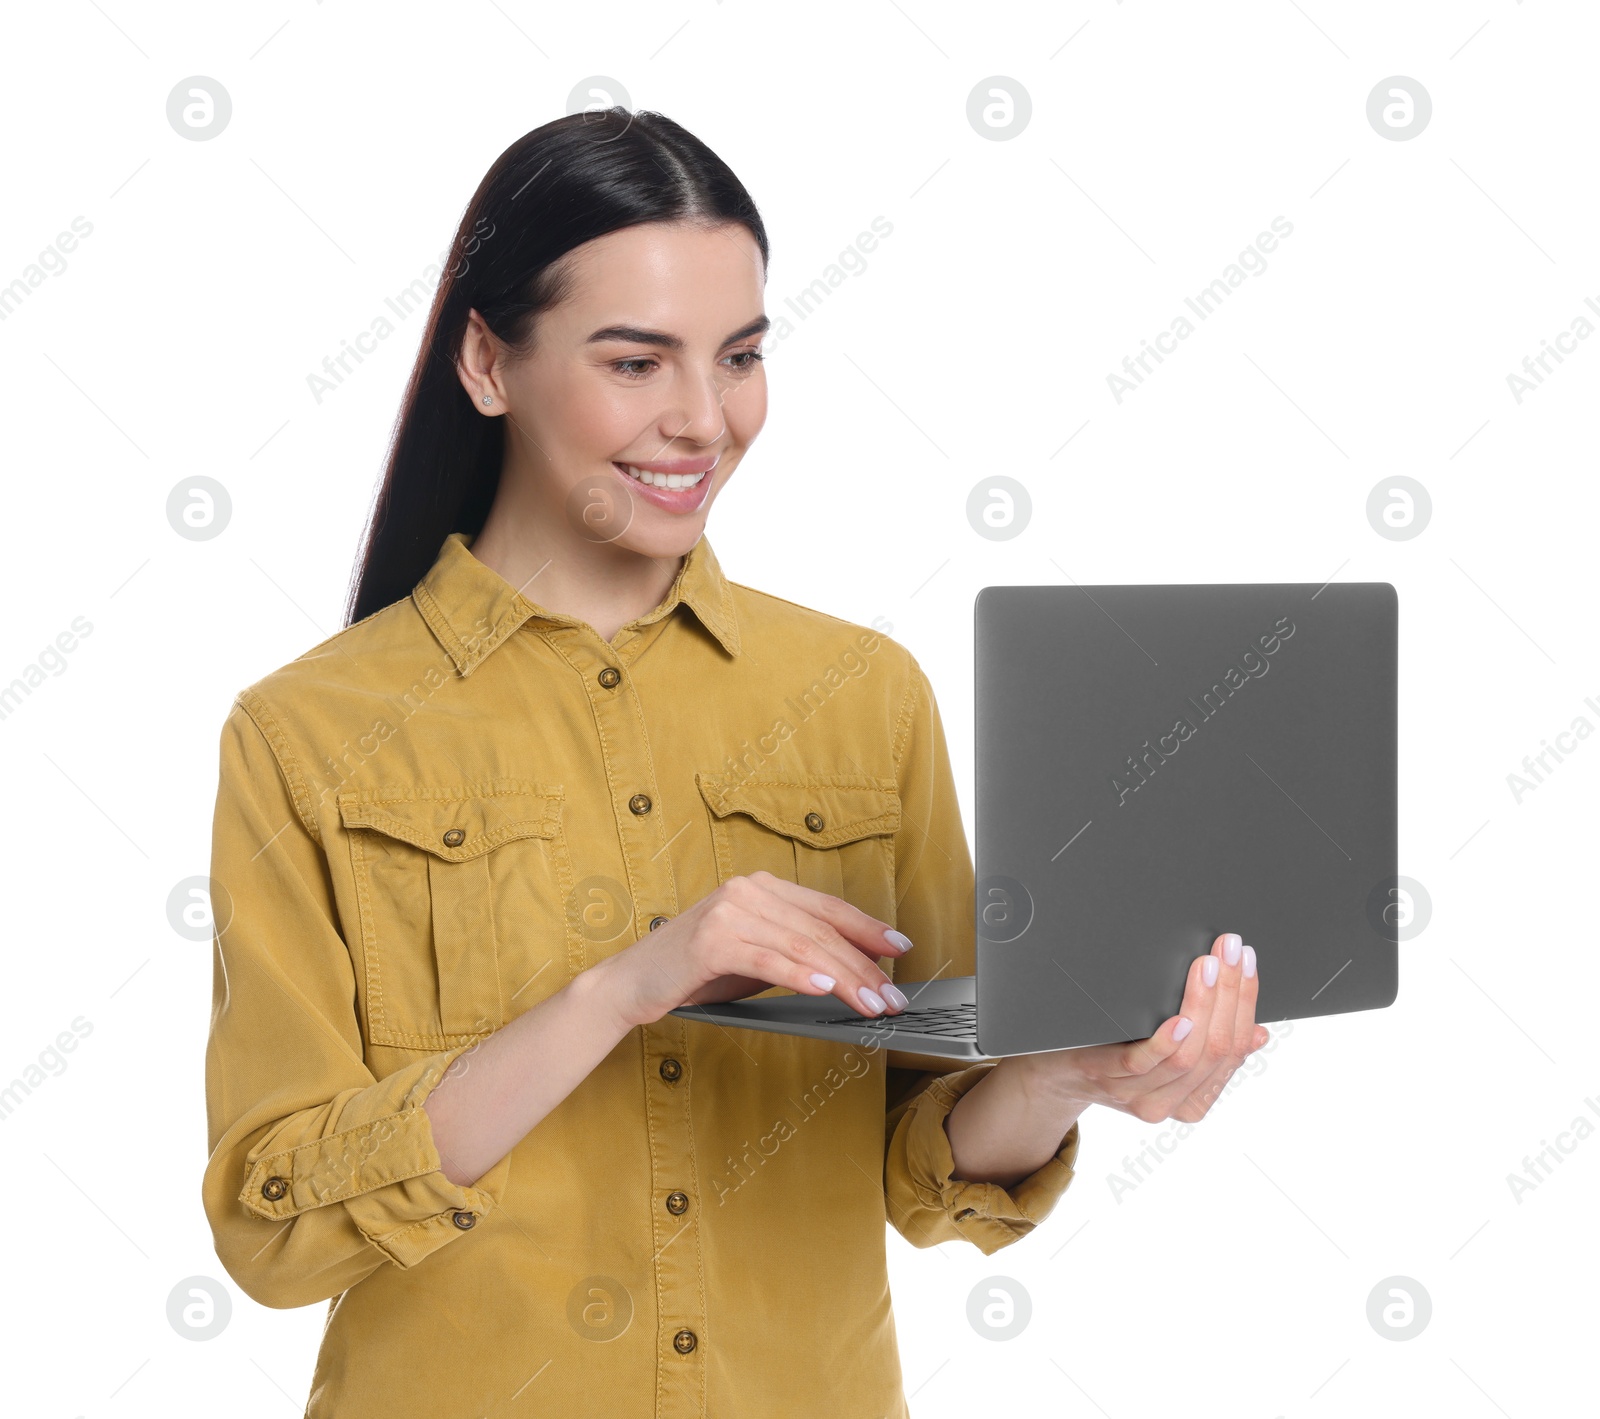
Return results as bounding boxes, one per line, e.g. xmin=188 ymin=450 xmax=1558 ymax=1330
xmin=590 ymin=872 xmax=910 ymax=1027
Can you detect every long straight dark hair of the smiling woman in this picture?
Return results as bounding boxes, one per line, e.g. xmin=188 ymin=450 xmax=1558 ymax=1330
xmin=344 ymin=107 xmax=768 ymax=626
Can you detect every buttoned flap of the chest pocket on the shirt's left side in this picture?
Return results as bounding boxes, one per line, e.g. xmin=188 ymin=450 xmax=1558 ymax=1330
xmin=339 ymin=779 xmax=562 ymax=862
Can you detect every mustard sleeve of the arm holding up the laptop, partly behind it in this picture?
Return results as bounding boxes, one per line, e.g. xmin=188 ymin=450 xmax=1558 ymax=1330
xmin=883 ymin=659 xmax=1078 ymax=1256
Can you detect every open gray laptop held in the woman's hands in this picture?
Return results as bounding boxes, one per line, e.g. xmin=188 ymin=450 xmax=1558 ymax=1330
xmin=672 ymin=582 xmax=1398 ymax=1059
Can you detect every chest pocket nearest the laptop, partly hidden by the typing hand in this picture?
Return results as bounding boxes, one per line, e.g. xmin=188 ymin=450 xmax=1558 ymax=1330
xmin=694 ymin=773 xmax=901 ymax=921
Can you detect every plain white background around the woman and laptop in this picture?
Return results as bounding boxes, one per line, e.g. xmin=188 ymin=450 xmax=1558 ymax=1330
xmin=0 ymin=0 xmax=1600 ymax=1419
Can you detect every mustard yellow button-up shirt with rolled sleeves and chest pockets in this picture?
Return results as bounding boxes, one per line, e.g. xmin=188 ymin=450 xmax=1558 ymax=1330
xmin=203 ymin=533 xmax=1078 ymax=1419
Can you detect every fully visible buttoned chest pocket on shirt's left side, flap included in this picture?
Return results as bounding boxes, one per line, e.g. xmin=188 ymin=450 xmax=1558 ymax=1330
xmin=339 ymin=779 xmax=571 ymax=1049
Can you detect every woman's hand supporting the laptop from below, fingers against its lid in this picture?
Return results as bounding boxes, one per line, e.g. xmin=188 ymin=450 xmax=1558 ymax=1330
xmin=1006 ymin=931 xmax=1270 ymax=1123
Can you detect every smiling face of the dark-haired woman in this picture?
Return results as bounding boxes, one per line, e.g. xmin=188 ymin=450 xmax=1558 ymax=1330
xmin=480 ymin=222 xmax=770 ymax=557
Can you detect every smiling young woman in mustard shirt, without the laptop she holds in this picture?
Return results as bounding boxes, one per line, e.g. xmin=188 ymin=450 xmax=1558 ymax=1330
xmin=205 ymin=109 xmax=1266 ymax=1419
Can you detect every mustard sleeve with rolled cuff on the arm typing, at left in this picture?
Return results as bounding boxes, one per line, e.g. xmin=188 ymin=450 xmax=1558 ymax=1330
xmin=202 ymin=691 xmax=510 ymax=1307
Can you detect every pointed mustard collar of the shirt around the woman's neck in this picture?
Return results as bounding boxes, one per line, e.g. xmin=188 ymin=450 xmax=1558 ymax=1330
xmin=411 ymin=533 xmax=739 ymax=675
